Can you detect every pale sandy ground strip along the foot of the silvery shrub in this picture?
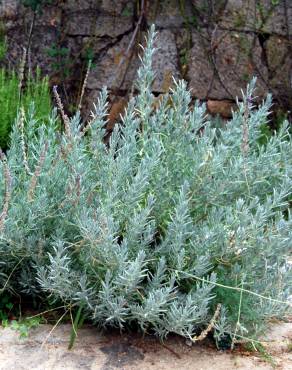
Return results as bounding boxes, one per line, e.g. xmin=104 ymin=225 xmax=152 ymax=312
xmin=0 ymin=323 xmax=292 ymax=370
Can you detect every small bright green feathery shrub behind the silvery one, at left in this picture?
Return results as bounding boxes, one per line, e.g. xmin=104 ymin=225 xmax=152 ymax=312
xmin=0 ymin=69 xmax=52 ymax=149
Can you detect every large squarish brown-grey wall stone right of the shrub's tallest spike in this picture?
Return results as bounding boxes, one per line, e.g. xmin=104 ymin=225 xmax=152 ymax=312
xmin=188 ymin=30 xmax=268 ymax=100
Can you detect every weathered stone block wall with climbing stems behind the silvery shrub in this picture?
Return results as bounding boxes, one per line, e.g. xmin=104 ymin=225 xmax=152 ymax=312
xmin=0 ymin=0 xmax=292 ymax=121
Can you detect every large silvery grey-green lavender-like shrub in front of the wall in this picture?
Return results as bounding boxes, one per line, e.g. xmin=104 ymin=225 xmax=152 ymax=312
xmin=0 ymin=29 xmax=292 ymax=342
